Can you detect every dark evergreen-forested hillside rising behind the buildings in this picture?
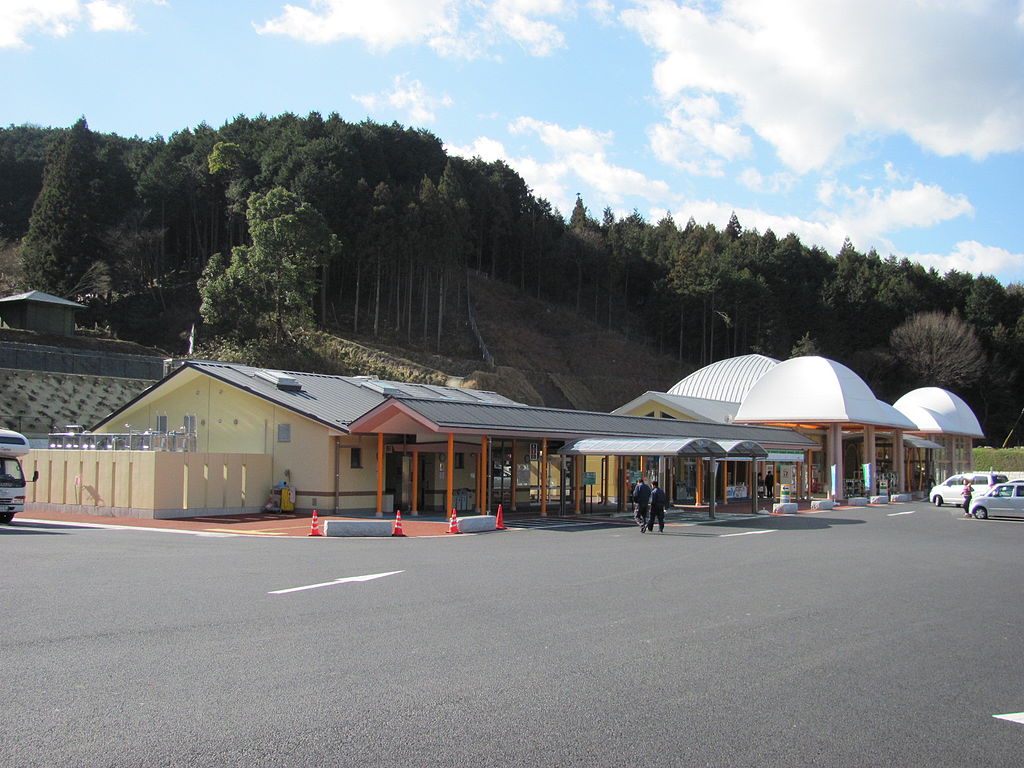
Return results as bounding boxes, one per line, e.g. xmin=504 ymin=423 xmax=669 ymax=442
xmin=0 ymin=114 xmax=1024 ymax=443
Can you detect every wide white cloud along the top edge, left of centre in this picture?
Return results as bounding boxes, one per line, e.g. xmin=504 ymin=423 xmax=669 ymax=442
xmin=256 ymin=0 xmax=574 ymax=58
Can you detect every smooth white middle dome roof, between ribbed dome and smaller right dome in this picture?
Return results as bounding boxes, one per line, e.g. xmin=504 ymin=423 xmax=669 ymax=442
xmin=736 ymin=356 xmax=914 ymax=429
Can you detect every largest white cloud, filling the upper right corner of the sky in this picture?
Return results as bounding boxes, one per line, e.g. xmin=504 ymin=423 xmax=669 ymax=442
xmin=621 ymin=0 xmax=1024 ymax=173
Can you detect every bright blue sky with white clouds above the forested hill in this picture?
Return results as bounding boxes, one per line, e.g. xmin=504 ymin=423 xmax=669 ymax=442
xmin=6 ymin=0 xmax=1024 ymax=285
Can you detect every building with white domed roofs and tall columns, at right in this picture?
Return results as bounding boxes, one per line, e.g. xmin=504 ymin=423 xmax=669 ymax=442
xmin=615 ymin=354 xmax=983 ymax=502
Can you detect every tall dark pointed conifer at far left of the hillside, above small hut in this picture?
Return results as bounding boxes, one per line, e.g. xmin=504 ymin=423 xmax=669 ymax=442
xmin=22 ymin=118 xmax=103 ymax=297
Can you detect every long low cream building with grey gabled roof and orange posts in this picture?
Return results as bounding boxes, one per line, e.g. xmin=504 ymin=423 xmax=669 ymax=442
xmin=22 ymin=360 xmax=815 ymax=518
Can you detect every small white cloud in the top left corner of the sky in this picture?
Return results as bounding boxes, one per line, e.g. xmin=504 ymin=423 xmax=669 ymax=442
xmin=0 ymin=0 xmax=149 ymax=48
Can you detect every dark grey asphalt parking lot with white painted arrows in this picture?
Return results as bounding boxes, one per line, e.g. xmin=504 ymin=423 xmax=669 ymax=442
xmin=0 ymin=505 xmax=1024 ymax=767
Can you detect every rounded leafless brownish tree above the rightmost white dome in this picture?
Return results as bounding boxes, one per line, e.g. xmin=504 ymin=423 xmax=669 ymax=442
xmin=889 ymin=312 xmax=985 ymax=388
